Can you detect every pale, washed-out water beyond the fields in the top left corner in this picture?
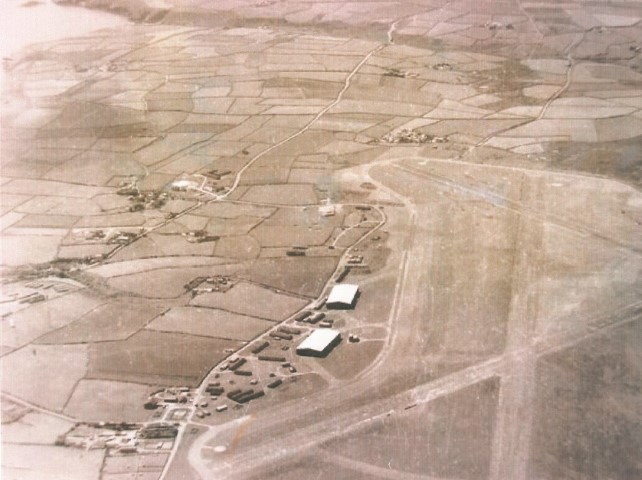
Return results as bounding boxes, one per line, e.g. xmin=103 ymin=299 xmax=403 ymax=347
xmin=0 ymin=0 xmax=129 ymax=58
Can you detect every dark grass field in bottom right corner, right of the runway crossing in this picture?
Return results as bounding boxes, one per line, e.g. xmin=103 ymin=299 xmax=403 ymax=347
xmin=529 ymin=320 xmax=642 ymax=479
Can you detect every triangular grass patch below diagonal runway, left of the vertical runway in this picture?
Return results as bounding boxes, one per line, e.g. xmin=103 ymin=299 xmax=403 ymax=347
xmin=325 ymin=380 xmax=499 ymax=480
